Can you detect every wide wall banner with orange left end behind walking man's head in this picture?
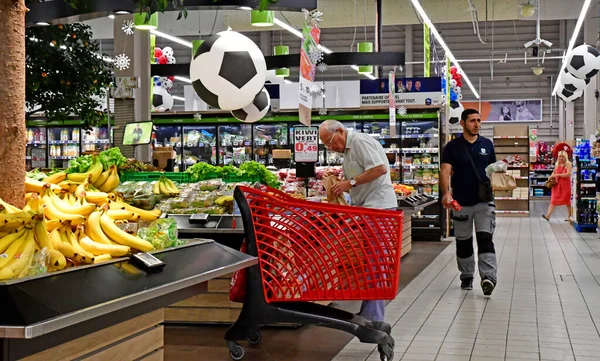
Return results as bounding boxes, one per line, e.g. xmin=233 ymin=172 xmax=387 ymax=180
xmin=462 ymin=99 xmax=543 ymax=123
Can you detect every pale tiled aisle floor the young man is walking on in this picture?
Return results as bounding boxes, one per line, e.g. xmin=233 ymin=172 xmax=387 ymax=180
xmin=334 ymin=204 xmax=600 ymax=361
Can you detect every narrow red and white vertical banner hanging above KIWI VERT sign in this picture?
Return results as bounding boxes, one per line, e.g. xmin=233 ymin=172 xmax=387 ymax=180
xmin=298 ymin=20 xmax=321 ymax=125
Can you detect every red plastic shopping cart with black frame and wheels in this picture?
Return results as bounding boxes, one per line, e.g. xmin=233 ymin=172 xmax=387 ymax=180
xmin=225 ymin=187 xmax=403 ymax=361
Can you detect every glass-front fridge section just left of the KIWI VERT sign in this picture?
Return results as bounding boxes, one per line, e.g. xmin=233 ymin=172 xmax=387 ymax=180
xmin=252 ymin=124 xmax=289 ymax=165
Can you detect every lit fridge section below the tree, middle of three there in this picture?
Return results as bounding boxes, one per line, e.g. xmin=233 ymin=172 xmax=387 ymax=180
xmin=48 ymin=127 xmax=81 ymax=168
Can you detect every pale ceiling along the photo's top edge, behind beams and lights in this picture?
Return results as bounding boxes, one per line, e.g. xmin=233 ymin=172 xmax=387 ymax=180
xmin=86 ymin=0 xmax=584 ymax=39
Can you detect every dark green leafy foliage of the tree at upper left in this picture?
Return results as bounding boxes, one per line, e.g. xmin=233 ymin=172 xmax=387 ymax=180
xmin=25 ymin=23 xmax=112 ymax=125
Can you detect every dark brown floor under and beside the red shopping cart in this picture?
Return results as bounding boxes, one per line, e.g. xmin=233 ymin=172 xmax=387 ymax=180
xmin=165 ymin=242 xmax=448 ymax=361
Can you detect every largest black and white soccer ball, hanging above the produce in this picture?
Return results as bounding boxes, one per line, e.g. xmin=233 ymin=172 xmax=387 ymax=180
xmin=190 ymin=31 xmax=267 ymax=111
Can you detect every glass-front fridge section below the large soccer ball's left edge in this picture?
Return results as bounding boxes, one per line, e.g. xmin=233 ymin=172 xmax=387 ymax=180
xmin=182 ymin=126 xmax=217 ymax=170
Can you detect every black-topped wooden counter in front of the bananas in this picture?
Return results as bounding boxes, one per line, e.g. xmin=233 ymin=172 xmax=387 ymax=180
xmin=0 ymin=240 xmax=257 ymax=361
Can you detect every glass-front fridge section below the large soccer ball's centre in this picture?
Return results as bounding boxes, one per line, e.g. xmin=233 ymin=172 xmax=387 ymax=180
xmin=219 ymin=124 xmax=252 ymax=166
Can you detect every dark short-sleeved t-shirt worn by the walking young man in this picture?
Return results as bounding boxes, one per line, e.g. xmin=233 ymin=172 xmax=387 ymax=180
xmin=442 ymin=135 xmax=496 ymax=207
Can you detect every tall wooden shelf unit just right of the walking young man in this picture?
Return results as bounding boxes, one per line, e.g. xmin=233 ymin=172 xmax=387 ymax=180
xmin=494 ymin=125 xmax=529 ymax=217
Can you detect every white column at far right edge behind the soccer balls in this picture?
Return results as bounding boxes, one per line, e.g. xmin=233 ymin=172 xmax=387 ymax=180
xmin=583 ymin=2 xmax=600 ymax=139
